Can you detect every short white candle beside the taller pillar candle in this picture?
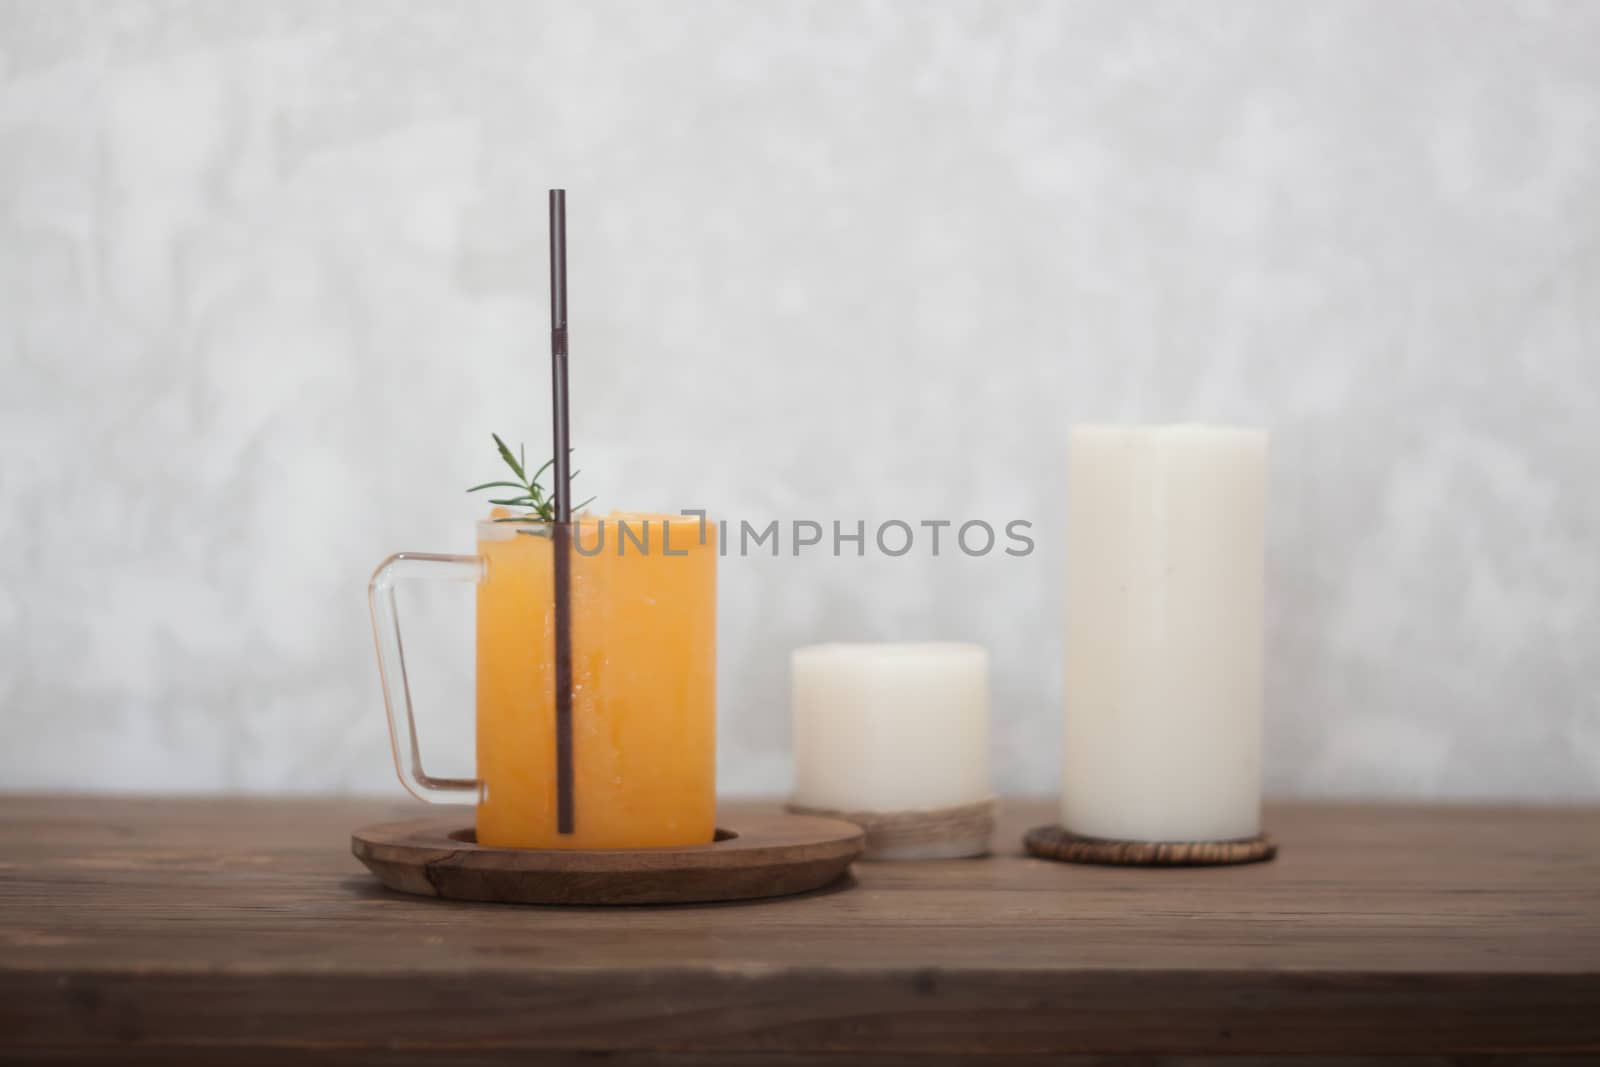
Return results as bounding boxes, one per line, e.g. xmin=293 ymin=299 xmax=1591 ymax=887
xmin=790 ymin=643 xmax=989 ymax=813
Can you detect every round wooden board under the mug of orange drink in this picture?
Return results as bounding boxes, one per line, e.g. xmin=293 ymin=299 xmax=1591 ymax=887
xmin=350 ymin=813 xmax=866 ymax=904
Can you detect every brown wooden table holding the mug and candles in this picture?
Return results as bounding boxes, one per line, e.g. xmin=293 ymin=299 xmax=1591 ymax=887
xmin=0 ymin=797 xmax=1600 ymax=1067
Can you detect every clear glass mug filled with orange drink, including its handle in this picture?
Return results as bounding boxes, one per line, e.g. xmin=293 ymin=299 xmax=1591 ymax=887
xmin=368 ymin=515 xmax=717 ymax=848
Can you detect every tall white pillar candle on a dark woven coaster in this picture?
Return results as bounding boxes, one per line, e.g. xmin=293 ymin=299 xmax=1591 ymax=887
xmin=1061 ymin=426 xmax=1267 ymax=841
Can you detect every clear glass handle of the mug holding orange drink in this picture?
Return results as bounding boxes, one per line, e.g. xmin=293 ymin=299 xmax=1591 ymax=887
xmin=366 ymin=552 xmax=485 ymax=805
